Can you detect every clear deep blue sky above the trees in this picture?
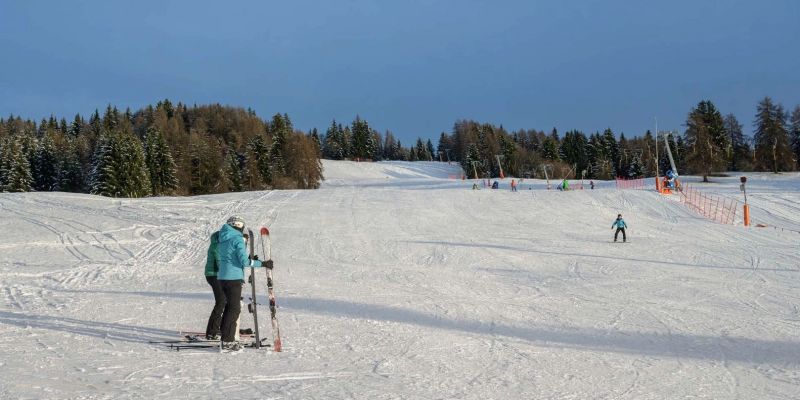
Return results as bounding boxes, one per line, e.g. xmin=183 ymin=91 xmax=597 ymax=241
xmin=0 ymin=0 xmax=800 ymax=145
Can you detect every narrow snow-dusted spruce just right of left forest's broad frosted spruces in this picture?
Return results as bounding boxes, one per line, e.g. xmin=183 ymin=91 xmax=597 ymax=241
xmin=144 ymin=125 xmax=178 ymax=196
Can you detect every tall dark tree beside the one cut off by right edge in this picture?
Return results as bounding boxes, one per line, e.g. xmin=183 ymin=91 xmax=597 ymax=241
xmin=753 ymin=97 xmax=794 ymax=174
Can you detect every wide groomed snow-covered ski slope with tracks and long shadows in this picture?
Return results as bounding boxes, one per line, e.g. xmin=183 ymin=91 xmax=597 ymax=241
xmin=0 ymin=161 xmax=800 ymax=399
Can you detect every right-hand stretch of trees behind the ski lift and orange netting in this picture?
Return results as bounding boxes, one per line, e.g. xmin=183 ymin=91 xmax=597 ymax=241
xmin=424 ymin=97 xmax=800 ymax=180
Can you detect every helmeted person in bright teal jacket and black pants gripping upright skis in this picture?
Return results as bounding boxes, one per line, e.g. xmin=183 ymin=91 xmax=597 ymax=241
xmin=214 ymin=216 xmax=272 ymax=351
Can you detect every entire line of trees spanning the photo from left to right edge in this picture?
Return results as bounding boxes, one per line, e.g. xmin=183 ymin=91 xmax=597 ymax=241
xmin=0 ymin=97 xmax=800 ymax=197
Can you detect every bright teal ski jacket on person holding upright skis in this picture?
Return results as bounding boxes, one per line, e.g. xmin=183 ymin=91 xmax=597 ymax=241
xmin=211 ymin=224 xmax=261 ymax=281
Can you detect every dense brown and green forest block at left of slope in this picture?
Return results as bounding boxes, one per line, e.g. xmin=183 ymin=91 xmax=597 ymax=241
xmin=0 ymin=100 xmax=322 ymax=197
